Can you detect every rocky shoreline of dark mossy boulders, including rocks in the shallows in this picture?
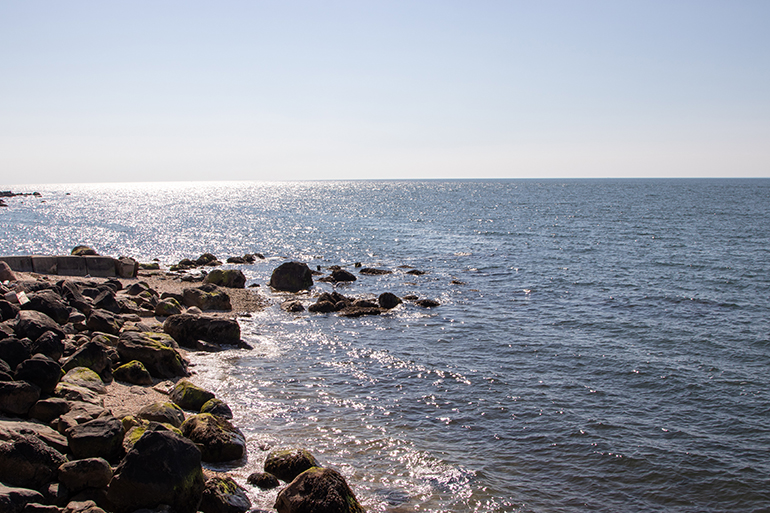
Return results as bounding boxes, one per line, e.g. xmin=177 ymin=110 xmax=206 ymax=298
xmin=0 ymin=255 xmax=378 ymax=513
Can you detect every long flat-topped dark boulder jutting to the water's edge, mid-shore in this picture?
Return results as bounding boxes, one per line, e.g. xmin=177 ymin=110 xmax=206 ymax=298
xmin=163 ymin=314 xmax=241 ymax=348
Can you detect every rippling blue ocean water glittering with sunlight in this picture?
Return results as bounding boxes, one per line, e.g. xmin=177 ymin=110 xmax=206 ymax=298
xmin=0 ymin=180 xmax=770 ymax=513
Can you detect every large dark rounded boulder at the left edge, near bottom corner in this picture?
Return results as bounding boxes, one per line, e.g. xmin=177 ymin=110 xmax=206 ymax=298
xmin=0 ymin=435 xmax=66 ymax=490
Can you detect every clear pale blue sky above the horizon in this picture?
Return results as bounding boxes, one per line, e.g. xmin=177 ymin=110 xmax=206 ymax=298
xmin=0 ymin=0 xmax=770 ymax=185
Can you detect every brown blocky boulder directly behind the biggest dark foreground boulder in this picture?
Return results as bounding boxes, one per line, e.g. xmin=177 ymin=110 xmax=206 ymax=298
xmin=65 ymin=416 xmax=125 ymax=461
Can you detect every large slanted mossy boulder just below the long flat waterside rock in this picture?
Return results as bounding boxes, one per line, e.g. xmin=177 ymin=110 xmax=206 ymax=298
xmin=118 ymin=331 xmax=188 ymax=379
